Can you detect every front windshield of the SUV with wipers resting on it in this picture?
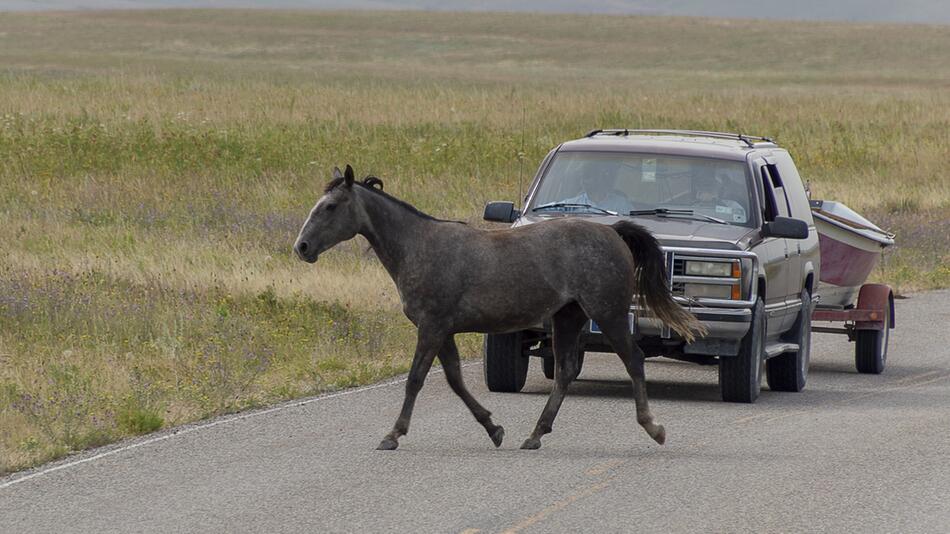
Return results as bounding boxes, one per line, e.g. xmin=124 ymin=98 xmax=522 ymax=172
xmin=530 ymin=152 xmax=751 ymax=226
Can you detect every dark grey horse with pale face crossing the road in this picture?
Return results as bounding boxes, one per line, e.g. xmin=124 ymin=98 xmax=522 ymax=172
xmin=294 ymin=165 xmax=700 ymax=450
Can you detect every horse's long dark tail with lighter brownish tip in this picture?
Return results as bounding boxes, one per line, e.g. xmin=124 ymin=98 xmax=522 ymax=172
xmin=611 ymin=221 xmax=706 ymax=341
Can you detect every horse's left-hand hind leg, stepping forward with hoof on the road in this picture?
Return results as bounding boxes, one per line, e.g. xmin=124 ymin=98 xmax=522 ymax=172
xmin=521 ymin=303 xmax=587 ymax=449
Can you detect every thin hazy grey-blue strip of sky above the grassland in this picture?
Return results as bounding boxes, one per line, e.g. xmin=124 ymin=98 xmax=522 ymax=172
xmin=0 ymin=0 xmax=950 ymax=24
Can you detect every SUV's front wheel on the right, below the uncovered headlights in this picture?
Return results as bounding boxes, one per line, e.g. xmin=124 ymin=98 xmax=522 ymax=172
xmin=719 ymin=297 xmax=765 ymax=402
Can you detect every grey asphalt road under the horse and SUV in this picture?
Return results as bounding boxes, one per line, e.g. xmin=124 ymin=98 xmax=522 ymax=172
xmin=0 ymin=291 xmax=950 ymax=533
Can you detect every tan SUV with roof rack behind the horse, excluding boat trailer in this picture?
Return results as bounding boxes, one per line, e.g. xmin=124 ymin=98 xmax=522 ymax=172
xmin=485 ymin=129 xmax=819 ymax=402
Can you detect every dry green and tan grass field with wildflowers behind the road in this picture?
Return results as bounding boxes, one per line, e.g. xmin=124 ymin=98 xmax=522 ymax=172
xmin=0 ymin=11 xmax=950 ymax=473
